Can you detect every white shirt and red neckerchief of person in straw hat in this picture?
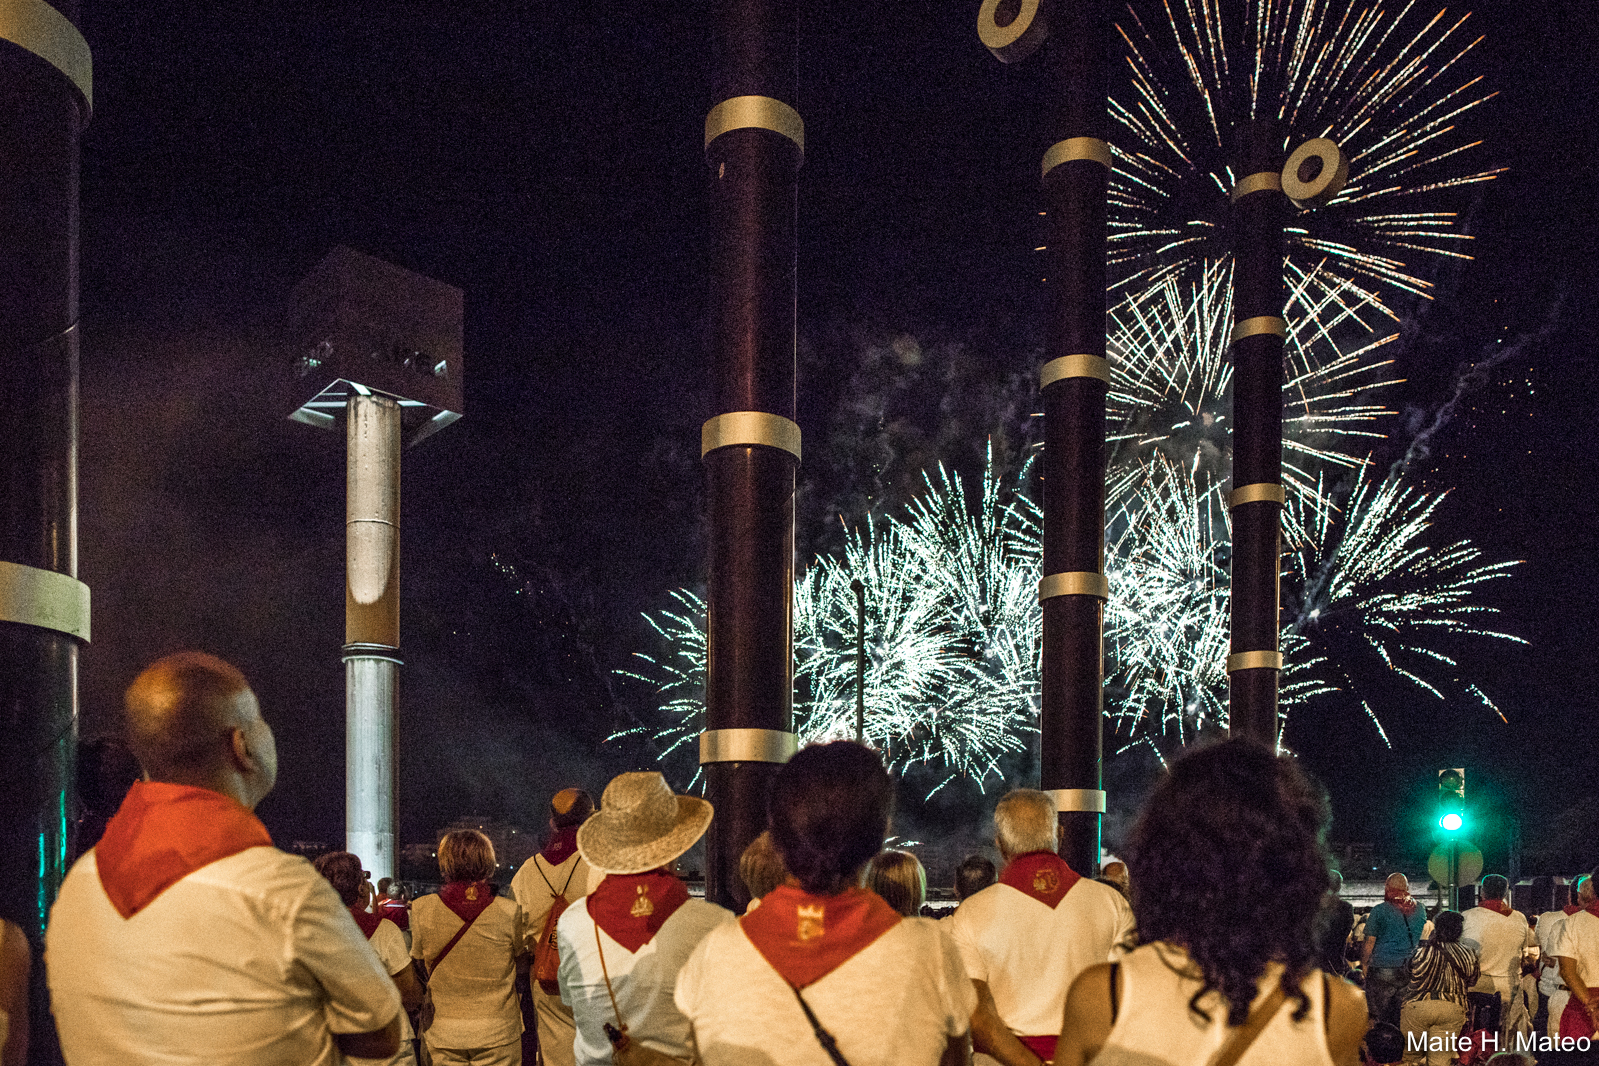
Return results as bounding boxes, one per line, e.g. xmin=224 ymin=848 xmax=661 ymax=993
xmin=558 ymin=871 xmax=732 ymax=1066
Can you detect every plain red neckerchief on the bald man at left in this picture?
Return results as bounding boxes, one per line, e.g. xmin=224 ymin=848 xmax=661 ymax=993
xmin=94 ymin=782 xmax=272 ymax=917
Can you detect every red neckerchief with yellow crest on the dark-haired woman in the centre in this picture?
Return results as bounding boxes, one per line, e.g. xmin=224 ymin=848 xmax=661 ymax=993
xmin=739 ymin=885 xmax=900 ymax=988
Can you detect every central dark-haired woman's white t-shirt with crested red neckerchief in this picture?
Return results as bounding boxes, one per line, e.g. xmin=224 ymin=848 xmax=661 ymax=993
xmin=676 ymin=885 xmax=972 ymax=1066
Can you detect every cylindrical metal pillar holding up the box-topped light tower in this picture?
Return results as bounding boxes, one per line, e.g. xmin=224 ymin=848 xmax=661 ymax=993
xmin=344 ymin=395 xmax=400 ymax=881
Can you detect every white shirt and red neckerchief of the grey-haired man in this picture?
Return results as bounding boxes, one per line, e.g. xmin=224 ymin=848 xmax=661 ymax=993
xmin=950 ymin=852 xmax=1132 ymax=1063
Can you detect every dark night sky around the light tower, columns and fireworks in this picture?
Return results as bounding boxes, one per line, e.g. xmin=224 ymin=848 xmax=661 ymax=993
xmin=71 ymin=0 xmax=1599 ymax=863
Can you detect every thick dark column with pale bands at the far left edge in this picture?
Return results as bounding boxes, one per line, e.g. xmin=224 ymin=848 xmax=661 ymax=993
xmin=0 ymin=0 xmax=90 ymax=1063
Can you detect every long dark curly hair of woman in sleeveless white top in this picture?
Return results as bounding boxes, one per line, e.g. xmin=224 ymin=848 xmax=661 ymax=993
xmin=1126 ymin=740 xmax=1332 ymax=1026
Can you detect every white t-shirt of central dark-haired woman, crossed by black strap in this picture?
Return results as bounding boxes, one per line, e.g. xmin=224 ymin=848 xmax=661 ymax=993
xmin=674 ymin=917 xmax=977 ymax=1066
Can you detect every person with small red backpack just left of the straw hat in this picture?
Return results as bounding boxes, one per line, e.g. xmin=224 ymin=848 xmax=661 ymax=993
xmin=510 ymin=788 xmax=595 ymax=1066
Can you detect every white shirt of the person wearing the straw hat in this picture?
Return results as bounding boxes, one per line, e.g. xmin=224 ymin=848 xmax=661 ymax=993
xmin=556 ymin=900 xmax=734 ymax=1066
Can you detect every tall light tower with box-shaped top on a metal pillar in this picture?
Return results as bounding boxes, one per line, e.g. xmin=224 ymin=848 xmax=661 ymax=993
xmin=288 ymin=248 xmax=464 ymax=879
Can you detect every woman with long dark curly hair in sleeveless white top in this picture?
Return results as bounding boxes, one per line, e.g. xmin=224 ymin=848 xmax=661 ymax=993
xmin=1054 ymin=740 xmax=1366 ymax=1066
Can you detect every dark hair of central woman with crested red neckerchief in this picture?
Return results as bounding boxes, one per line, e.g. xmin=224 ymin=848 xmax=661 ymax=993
xmin=766 ymin=740 xmax=894 ymax=895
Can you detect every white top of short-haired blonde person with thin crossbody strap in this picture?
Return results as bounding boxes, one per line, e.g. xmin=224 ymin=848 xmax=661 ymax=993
xmin=411 ymin=895 xmax=528 ymax=1047
